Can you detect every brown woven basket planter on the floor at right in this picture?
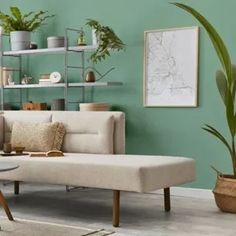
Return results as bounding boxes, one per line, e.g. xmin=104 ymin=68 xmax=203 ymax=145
xmin=213 ymin=175 xmax=236 ymax=213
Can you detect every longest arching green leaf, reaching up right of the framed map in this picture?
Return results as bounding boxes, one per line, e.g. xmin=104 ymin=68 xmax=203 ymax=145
xmin=172 ymin=3 xmax=233 ymax=87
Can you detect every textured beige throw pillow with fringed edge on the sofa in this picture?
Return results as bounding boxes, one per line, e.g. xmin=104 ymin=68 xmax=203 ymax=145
xmin=11 ymin=122 xmax=66 ymax=152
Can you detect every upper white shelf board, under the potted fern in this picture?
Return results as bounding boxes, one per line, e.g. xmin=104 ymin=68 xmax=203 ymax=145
xmin=3 ymin=45 xmax=96 ymax=56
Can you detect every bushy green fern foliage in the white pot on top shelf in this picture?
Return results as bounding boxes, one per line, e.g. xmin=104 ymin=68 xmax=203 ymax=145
xmin=0 ymin=7 xmax=54 ymax=33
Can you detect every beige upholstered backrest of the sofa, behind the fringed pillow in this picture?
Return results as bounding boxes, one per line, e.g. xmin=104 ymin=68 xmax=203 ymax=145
xmin=0 ymin=111 xmax=125 ymax=154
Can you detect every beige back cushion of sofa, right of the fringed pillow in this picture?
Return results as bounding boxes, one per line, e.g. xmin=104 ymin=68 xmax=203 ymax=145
xmin=52 ymin=112 xmax=114 ymax=154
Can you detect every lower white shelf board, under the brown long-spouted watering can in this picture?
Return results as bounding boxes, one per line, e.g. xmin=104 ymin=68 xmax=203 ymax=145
xmin=4 ymin=82 xmax=123 ymax=89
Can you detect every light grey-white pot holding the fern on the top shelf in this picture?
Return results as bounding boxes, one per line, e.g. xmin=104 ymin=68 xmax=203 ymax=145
xmin=10 ymin=31 xmax=31 ymax=51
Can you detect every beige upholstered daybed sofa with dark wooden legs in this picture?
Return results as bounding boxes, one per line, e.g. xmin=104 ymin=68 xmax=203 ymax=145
xmin=0 ymin=111 xmax=195 ymax=226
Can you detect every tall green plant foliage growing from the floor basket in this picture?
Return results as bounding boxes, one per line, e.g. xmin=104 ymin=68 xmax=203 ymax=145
xmin=173 ymin=3 xmax=236 ymax=176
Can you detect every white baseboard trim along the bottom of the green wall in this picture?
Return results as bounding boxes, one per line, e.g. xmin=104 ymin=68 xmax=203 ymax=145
xmin=152 ymin=187 xmax=214 ymax=199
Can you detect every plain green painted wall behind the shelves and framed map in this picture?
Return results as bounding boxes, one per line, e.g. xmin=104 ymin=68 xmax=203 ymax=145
xmin=0 ymin=0 xmax=236 ymax=188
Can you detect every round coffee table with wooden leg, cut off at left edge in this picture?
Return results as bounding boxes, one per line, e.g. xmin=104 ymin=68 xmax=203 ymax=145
xmin=0 ymin=161 xmax=19 ymax=221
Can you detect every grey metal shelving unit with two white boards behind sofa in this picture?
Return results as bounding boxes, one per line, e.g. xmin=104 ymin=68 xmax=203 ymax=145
xmin=0 ymin=28 xmax=122 ymax=110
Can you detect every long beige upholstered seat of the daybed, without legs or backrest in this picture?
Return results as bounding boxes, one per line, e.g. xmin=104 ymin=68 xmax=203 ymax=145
xmin=0 ymin=153 xmax=195 ymax=192
